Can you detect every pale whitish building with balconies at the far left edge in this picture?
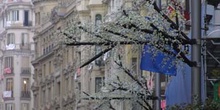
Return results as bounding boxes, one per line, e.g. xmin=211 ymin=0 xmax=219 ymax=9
xmin=0 ymin=0 xmax=34 ymax=110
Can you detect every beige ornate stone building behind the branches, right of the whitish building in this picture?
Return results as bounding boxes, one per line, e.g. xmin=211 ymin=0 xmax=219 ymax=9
xmin=32 ymin=0 xmax=160 ymax=110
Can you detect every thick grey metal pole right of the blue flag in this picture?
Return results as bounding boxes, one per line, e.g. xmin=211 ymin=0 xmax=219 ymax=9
xmin=191 ymin=0 xmax=201 ymax=104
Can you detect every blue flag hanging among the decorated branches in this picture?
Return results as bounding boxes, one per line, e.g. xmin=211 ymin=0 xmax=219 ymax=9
xmin=140 ymin=45 xmax=176 ymax=76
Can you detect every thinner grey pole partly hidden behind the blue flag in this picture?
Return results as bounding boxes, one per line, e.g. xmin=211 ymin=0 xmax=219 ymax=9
xmin=155 ymin=0 xmax=161 ymax=110
